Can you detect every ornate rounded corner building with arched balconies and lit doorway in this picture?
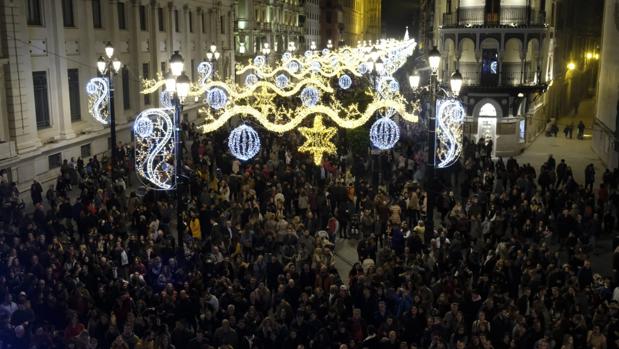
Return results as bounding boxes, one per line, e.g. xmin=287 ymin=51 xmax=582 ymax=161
xmin=432 ymin=0 xmax=553 ymax=156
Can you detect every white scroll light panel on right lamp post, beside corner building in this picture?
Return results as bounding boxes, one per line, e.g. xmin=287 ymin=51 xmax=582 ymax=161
xmin=434 ymin=99 xmax=466 ymax=168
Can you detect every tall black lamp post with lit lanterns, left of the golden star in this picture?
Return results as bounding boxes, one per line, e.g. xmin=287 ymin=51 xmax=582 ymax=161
xmin=166 ymin=51 xmax=190 ymax=258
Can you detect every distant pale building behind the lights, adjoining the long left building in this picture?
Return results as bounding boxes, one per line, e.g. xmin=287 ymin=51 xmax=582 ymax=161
xmin=235 ymin=0 xmax=309 ymax=61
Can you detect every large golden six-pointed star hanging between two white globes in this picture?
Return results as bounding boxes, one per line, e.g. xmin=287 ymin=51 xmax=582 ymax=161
xmin=299 ymin=115 xmax=337 ymax=166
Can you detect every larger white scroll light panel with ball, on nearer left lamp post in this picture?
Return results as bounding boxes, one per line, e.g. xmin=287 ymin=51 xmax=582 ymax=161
xmin=133 ymin=108 xmax=175 ymax=190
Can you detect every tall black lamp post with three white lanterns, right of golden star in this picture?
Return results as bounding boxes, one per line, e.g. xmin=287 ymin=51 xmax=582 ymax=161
xmin=408 ymin=46 xmax=463 ymax=234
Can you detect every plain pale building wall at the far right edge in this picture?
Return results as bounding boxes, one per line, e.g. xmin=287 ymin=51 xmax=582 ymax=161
xmin=593 ymin=0 xmax=619 ymax=170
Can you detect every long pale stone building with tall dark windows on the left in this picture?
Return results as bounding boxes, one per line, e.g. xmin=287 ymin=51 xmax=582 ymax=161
xmin=0 ymin=0 xmax=235 ymax=191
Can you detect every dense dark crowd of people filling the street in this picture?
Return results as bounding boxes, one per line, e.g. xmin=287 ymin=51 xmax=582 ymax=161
xmin=0 ymin=120 xmax=619 ymax=349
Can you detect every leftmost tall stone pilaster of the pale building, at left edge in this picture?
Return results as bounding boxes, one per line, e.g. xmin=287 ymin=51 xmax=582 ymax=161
xmin=0 ymin=1 xmax=41 ymax=150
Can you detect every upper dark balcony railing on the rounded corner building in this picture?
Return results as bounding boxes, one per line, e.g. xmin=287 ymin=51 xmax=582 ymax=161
xmin=443 ymin=6 xmax=546 ymax=27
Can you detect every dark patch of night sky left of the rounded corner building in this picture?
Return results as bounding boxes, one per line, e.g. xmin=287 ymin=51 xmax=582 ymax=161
xmin=382 ymin=0 xmax=420 ymax=38
